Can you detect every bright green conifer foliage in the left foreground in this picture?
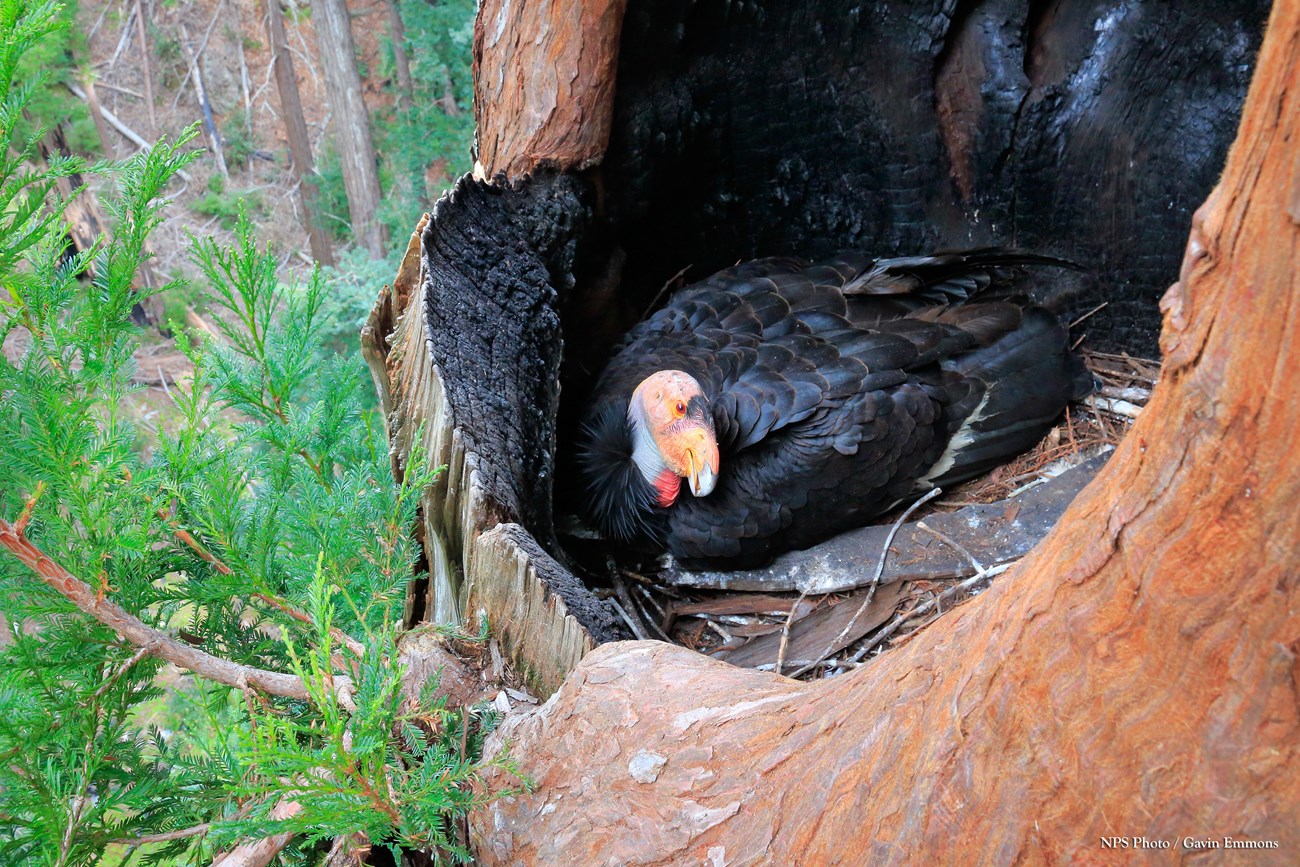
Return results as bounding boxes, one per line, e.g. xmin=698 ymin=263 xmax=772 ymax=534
xmin=0 ymin=0 xmax=517 ymax=866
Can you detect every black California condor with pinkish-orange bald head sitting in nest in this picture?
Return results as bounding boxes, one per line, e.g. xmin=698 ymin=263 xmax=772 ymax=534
xmin=579 ymin=250 xmax=1092 ymax=568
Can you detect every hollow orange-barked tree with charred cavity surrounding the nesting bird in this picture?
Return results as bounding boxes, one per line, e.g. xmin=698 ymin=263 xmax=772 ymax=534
xmin=365 ymin=0 xmax=1300 ymax=863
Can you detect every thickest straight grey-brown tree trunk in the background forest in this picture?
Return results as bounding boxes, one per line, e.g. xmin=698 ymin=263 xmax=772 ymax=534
xmin=312 ymin=0 xmax=387 ymax=259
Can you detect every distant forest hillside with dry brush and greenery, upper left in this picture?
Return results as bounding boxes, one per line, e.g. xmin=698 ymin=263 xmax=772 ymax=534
xmin=17 ymin=0 xmax=477 ymax=363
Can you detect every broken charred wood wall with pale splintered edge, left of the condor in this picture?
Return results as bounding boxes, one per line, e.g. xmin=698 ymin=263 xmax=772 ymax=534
xmin=361 ymin=177 xmax=624 ymax=693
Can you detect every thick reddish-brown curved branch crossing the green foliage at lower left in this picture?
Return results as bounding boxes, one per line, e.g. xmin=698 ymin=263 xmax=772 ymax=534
xmin=0 ymin=517 xmax=356 ymax=711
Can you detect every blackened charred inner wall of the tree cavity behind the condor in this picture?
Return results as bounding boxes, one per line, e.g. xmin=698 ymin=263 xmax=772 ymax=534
xmin=603 ymin=0 xmax=1269 ymax=355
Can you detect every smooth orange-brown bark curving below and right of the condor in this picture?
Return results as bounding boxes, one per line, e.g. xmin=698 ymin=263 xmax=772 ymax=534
xmin=473 ymin=0 xmax=1300 ymax=864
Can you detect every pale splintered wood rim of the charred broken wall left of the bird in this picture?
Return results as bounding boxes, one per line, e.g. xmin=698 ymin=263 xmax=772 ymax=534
xmin=361 ymin=214 xmax=595 ymax=695
